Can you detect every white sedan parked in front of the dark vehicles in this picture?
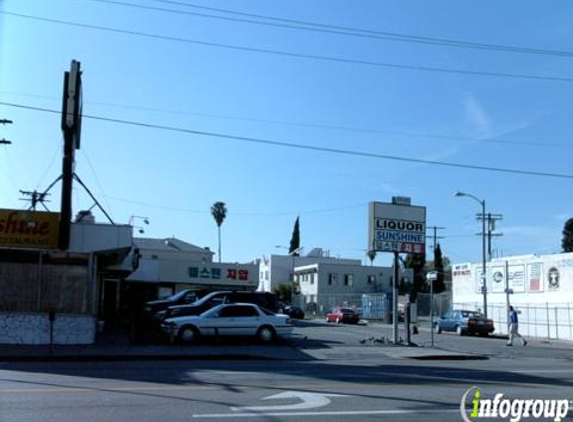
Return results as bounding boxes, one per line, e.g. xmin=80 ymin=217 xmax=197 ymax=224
xmin=161 ymin=303 xmax=292 ymax=343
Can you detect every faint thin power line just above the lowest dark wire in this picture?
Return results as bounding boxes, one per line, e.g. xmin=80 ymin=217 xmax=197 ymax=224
xmin=4 ymin=90 xmax=573 ymax=149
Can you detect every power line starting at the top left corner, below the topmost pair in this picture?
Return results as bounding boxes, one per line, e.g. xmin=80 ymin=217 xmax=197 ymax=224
xmin=4 ymin=11 xmax=573 ymax=82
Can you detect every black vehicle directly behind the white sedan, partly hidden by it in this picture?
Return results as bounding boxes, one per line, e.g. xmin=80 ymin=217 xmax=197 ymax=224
xmin=155 ymin=291 xmax=279 ymax=321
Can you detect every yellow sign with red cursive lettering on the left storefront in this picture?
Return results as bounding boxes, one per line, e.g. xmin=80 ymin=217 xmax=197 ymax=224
xmin=0 ymin=209 xmax=60 ymax=249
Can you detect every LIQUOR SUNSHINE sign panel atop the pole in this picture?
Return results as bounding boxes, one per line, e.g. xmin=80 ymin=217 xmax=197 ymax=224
xmin=368 ymin=202 xmax=426 ymax=254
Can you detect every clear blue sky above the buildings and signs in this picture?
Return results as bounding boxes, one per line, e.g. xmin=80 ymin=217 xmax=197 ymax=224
xmin=0 ymin=0 xmax=573 ymax=263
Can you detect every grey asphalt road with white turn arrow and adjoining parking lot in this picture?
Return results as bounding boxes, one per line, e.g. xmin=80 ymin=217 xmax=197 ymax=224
xmin=0 ymin=322 xmax=573 ymax=422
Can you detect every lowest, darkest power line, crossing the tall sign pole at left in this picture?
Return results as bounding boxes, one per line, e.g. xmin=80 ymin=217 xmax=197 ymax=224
xmin=4 ymin=101 xmax=573 ymax=179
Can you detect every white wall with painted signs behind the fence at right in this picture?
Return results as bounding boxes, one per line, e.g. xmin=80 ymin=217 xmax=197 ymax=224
xmin=452 ymin=253 xmax=573 ymax=340
